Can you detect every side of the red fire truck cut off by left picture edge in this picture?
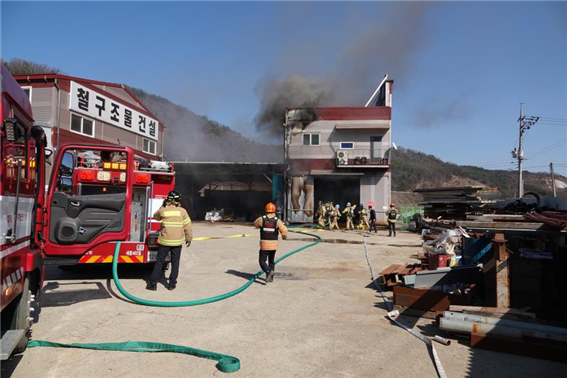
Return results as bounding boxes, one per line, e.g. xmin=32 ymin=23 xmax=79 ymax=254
xmin=0 ymin=65 xmax=46 ymax=360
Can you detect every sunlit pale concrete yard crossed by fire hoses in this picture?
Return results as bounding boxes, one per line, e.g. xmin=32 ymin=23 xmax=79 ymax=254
xmin=2 ymin=223 xmax=567 ymax=378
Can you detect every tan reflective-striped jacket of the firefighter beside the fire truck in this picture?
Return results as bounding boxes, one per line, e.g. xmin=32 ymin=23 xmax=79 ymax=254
xmin=154 ymin=205 xmax=193 ymax=247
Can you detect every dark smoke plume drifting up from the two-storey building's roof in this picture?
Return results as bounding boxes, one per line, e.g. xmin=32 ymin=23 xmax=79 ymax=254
xmin=255 ymin=2 xmax=432 ymax=137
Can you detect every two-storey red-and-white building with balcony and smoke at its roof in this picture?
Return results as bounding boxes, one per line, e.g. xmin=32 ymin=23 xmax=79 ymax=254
xmin=284 ymin=80 xmax=393 ymax=224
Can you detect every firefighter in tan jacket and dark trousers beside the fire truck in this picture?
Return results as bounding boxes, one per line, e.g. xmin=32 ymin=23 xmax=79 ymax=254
xmin=146 ymin=190 xmax=193 ymax=291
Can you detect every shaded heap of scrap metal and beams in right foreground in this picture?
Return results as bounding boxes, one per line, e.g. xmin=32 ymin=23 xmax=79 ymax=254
xmin=380 ymin=202 xmax=567 ymax=363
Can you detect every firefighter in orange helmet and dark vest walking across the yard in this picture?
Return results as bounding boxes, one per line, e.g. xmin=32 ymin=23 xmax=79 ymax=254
xmin=254 ymin=202 xmax=287 ymax=283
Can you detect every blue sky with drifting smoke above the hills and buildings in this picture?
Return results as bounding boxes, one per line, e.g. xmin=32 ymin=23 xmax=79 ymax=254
xmin=0 ymin=1 xmax=567 ymax=176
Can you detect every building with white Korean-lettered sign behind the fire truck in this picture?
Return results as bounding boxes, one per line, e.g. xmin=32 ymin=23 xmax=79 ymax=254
xmin=14 ymin=74 xmax=165 ymax=160
